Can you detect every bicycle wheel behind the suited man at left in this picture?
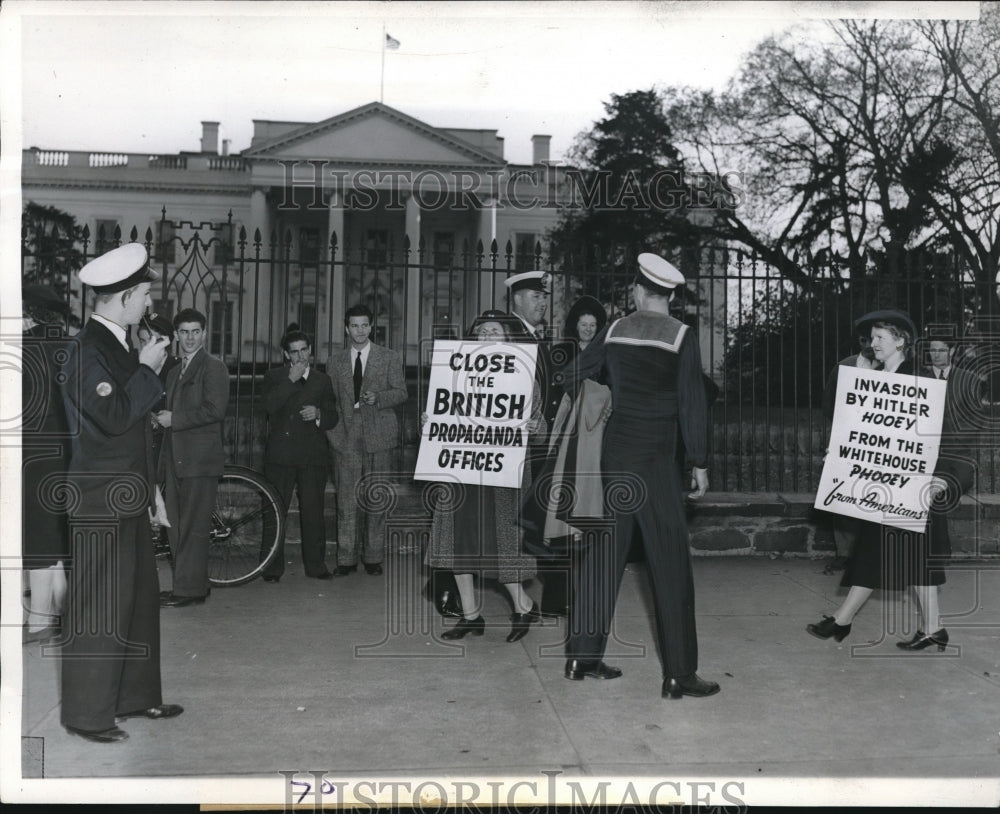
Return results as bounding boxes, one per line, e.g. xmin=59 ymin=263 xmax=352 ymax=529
xmin=208 ymin=466 xmax=285 ymax=587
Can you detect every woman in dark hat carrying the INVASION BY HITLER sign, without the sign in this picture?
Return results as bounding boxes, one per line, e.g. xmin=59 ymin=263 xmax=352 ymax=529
xmin=806 ymin=310 xmax=972 ymax=650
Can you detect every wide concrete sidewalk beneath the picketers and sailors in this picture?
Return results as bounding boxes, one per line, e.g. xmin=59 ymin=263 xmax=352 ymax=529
xmin=13 ymin=546 xmax=1000 ymax=806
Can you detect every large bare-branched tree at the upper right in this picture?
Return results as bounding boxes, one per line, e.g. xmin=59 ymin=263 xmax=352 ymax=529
xmin=664 ymin=12 xmax=1000 ymax=316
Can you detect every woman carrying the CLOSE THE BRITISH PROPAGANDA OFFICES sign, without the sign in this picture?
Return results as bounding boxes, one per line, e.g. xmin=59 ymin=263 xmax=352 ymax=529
xmin=420 ymin=311 xmax=545 ymax=642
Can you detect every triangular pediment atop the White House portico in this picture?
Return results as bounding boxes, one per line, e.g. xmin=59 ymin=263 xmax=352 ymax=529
xmin=243 ymin=102 xmax=504 ymax=166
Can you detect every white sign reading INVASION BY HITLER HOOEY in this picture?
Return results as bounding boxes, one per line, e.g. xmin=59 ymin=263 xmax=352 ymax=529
xmin=815 ymin=366 xmax=946 ymax=531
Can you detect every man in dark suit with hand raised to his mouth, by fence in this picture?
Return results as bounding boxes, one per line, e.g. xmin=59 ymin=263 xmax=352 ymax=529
xmin=261 ymin=330 xmax=338 ymax=582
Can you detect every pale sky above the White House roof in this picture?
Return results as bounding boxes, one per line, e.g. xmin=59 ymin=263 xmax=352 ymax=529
xmin=0 ymin=0 xmax=976 ymax=163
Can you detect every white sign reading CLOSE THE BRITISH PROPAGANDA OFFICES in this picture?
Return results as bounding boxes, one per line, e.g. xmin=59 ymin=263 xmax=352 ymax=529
xmin=413 ymin=340 xmax=538 ymax=488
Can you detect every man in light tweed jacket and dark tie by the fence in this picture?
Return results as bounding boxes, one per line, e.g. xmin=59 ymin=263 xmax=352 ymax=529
xmin=329 ymin=305 xmax=406 ymax=577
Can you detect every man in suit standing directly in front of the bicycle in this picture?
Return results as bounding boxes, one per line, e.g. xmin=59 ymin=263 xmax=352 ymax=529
xmin=156 ymin=308 xmax=229 ymax=608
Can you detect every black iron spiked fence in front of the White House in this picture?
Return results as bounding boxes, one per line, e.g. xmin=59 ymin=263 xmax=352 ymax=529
xmin=22 ymin=212 xmax=1000 ymax=493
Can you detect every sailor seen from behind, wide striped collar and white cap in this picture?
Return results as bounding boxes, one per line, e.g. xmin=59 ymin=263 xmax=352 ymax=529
xmin=564 ymin=254 xmax=719 ymax=698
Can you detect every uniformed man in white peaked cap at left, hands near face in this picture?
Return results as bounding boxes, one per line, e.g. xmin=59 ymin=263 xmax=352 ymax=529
xmin=61 ymin=243 xmax=184 ymax=743
